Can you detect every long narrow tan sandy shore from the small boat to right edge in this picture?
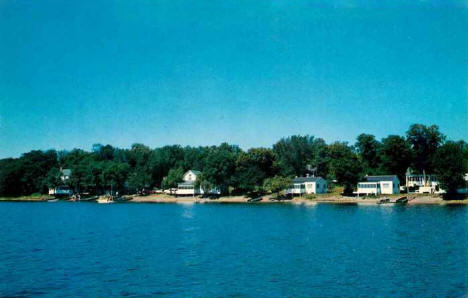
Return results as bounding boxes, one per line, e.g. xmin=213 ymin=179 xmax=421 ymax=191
xmin=129 ymin=194 xmax=468 ymax=205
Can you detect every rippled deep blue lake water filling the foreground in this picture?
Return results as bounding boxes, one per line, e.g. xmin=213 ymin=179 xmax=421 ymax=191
xmin=0 ymin=203 xmax=468 ymax=297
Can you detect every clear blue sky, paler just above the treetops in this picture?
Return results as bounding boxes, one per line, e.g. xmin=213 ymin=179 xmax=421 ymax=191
xmin=0 ymin=0 xmax=468 ymax=158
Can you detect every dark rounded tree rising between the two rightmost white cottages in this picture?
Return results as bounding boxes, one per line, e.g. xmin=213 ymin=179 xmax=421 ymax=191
xmin=379 ymin=135 xmax=413 ymax=181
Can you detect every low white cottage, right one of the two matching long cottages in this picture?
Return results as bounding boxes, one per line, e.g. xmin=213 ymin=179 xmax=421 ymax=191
xmin=355 ymin=175 xmax=400 ymax=195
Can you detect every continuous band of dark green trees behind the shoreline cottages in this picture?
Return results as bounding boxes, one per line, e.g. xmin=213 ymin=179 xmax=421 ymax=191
xmin=0 ymin=124 xmax=468 ymax=196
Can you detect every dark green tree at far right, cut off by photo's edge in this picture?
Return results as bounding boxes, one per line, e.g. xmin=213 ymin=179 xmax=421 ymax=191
xmin=434 ymin=141 xmax=466 ymax=194
